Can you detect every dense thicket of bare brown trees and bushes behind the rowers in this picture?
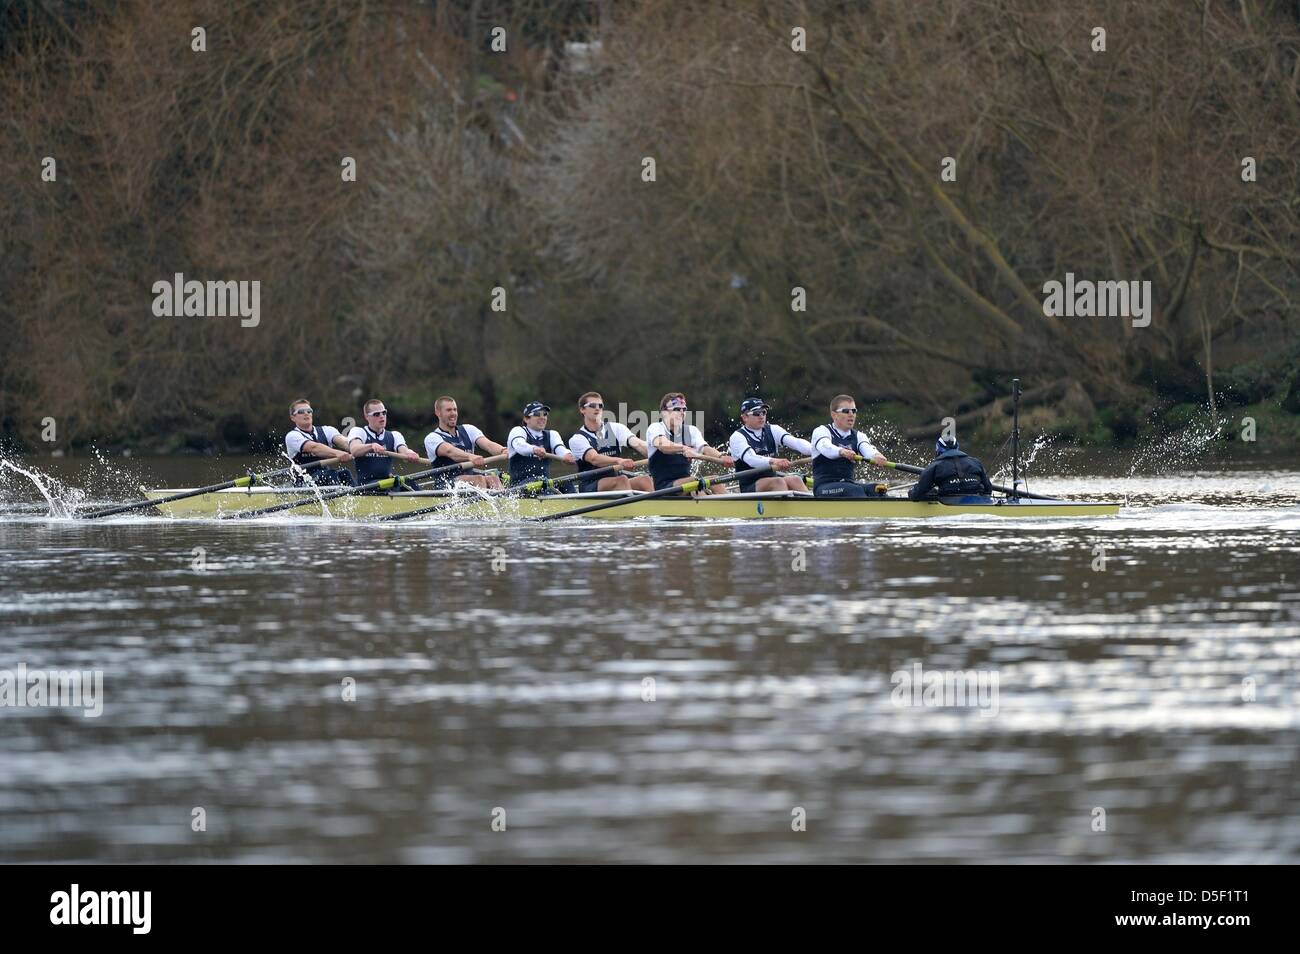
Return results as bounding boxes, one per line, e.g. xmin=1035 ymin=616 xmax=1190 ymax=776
xmin=0 ymin=0 xmax=1300 ymax=445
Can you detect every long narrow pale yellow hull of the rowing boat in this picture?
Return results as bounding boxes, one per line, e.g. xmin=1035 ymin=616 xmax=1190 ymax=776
xmin=139 ymin=487 xmax=1119 ymax=520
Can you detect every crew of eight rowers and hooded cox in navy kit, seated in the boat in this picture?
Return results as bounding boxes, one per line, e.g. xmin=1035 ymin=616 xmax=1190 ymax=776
xmin=285 ymin=391 xmax=989 ymax=499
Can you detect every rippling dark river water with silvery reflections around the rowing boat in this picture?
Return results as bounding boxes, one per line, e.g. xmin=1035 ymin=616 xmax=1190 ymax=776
xmin=0 ymin=459 xmax=1300 ymax=862
